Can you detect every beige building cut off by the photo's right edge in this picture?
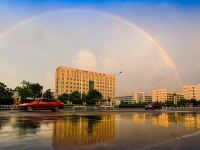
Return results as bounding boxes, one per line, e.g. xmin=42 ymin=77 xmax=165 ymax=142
xmin=183 ymin=84 xmax=200 ymax=100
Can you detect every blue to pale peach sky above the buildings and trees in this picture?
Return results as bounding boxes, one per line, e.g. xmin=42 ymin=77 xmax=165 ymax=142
xmin=0 ymin=0 xmax=200 ymax=95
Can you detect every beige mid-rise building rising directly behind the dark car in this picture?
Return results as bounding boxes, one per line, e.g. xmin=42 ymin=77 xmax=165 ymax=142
xmin=152 ymin=89 xmax=173 ymax=102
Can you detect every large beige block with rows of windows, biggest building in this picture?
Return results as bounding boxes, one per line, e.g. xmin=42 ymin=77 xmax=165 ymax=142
xmin=55 ymin=66 xmax=116 ymax=102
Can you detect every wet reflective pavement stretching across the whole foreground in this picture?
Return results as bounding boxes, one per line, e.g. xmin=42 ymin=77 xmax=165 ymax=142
xmin=0 ymin=111 xmax=200 ymax=150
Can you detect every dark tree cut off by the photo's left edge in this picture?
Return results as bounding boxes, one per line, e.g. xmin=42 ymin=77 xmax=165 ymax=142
xmin=0 ymin=82 xmax=13 ymax=98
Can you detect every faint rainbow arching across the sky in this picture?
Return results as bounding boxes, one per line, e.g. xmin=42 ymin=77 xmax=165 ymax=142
xmin=0 ymin=9 xmax=182 ymax=85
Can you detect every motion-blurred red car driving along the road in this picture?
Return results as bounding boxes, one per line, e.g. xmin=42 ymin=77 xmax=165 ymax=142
xmin=19 ymin=99 xmax=64 ymax=111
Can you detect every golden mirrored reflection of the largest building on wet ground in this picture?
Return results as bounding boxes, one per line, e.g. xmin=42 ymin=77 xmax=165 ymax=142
xmin=53 ymin=115 xmax=115 ymax=148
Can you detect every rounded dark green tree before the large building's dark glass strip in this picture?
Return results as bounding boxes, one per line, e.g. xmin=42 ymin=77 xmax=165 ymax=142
xmin=87 ymin=89 xmax=103 ymax=104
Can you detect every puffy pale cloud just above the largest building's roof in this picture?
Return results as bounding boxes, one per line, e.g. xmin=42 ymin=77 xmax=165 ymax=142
xmin=73 ymin=49 xmax=97 ymax=70
